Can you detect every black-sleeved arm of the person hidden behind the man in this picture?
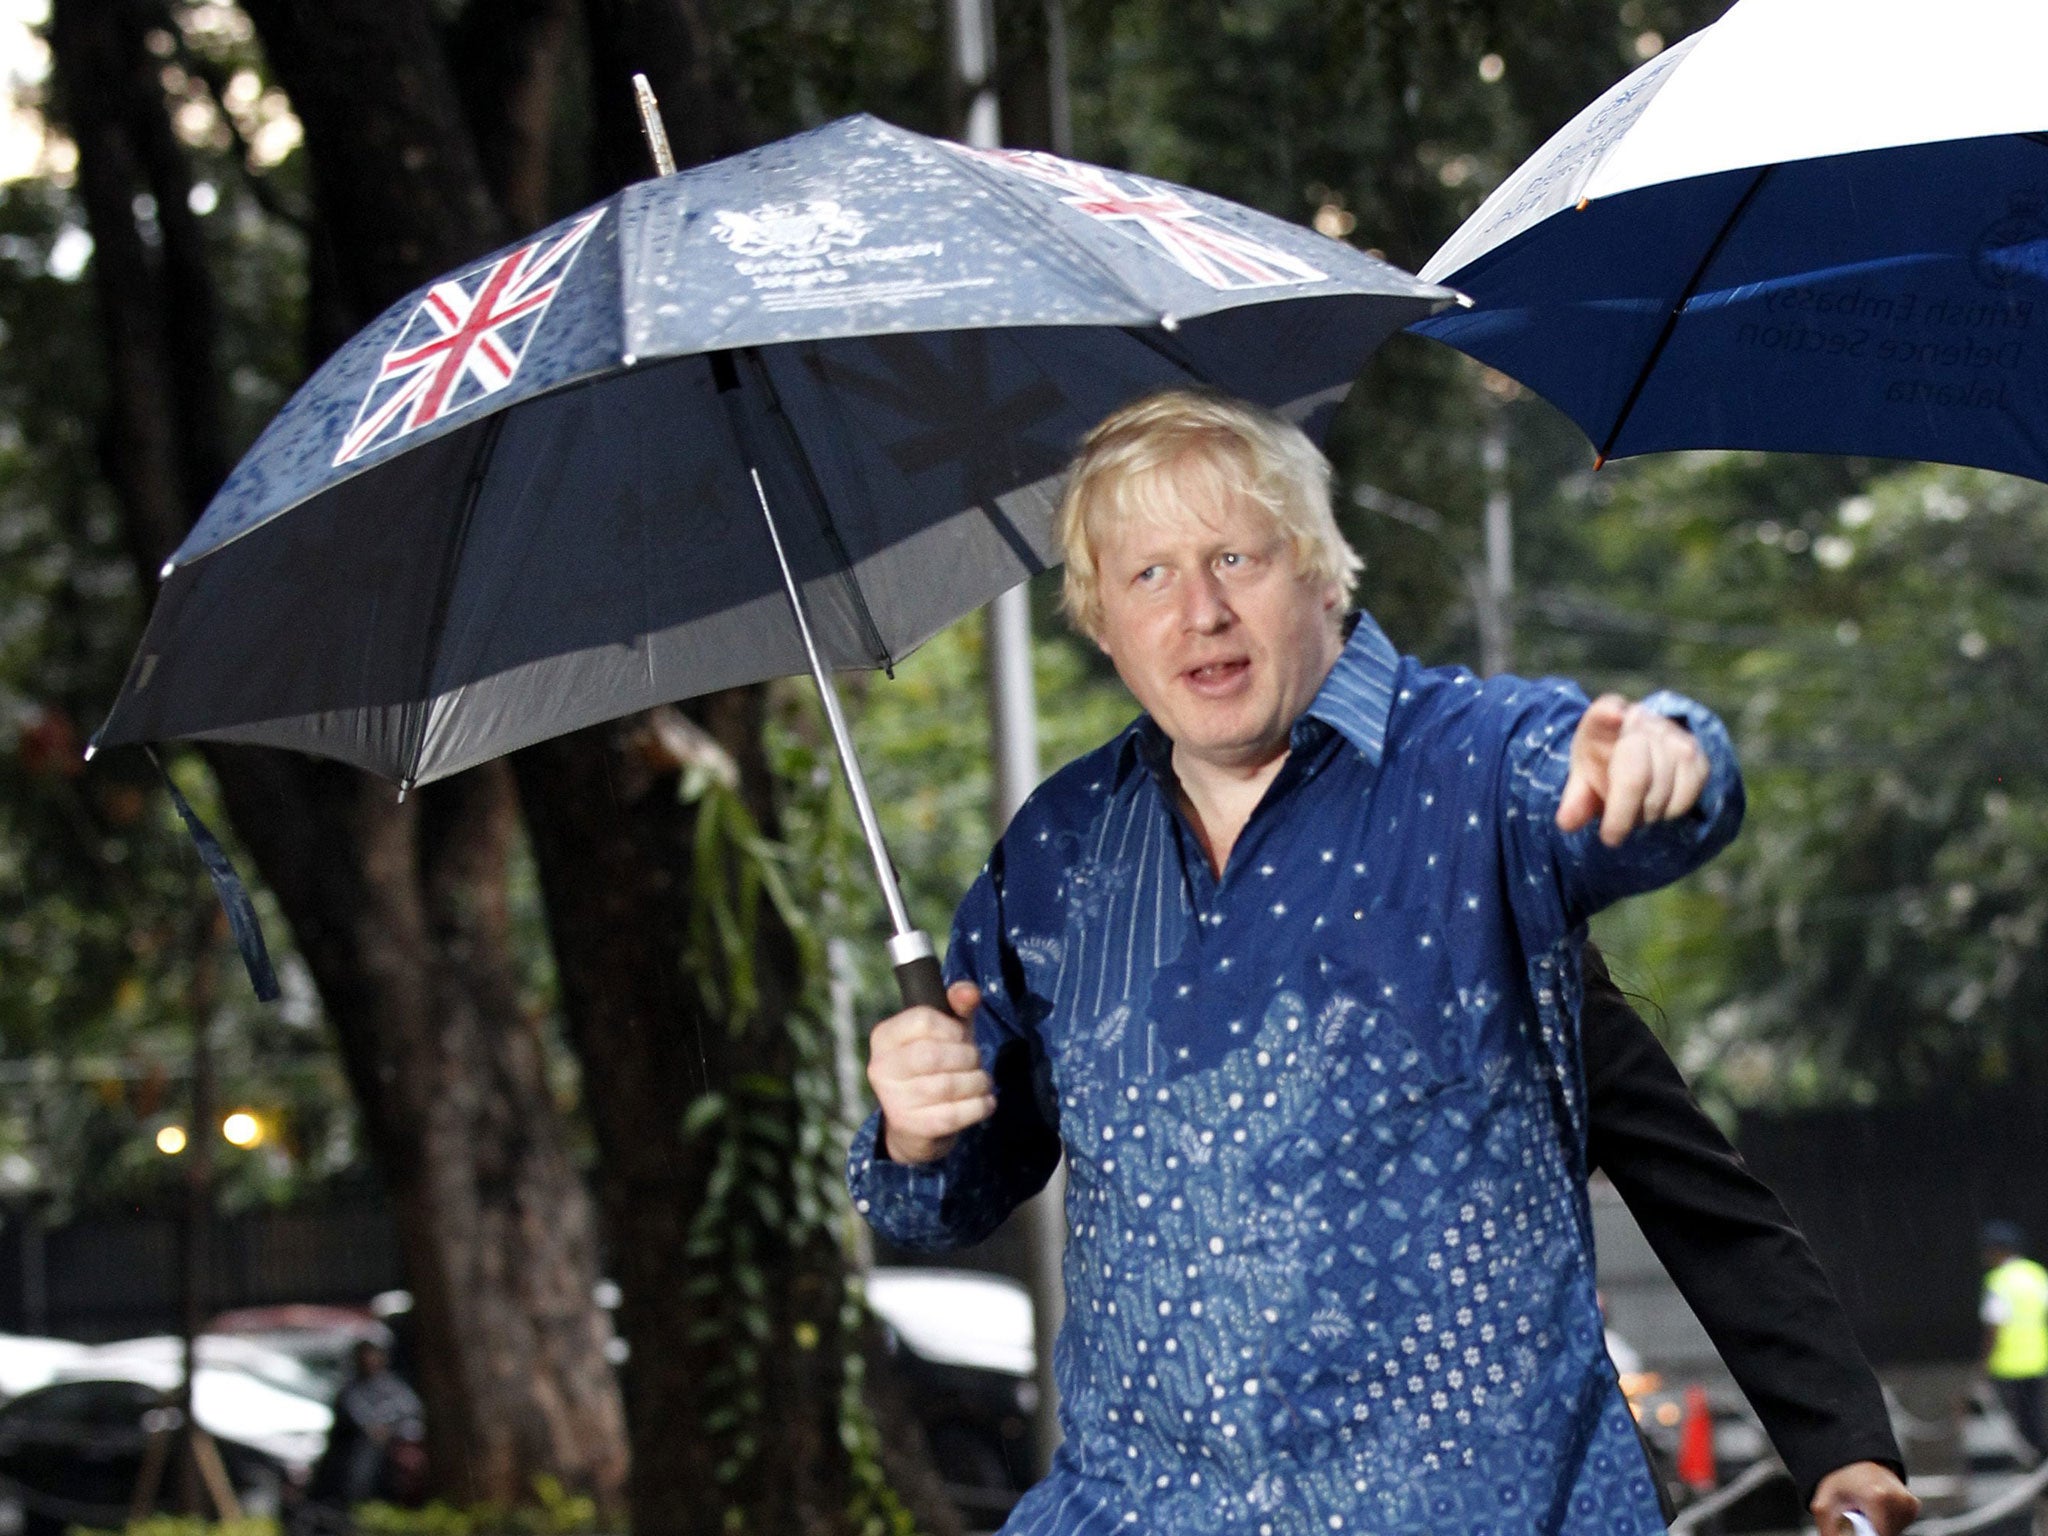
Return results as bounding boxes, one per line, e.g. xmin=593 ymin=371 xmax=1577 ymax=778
xmin=1581 ymin=944 xmax=1919 ymax=1536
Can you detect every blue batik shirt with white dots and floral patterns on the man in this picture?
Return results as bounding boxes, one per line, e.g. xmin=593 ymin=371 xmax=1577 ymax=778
xmin=848 ymin=618 xmax=1743 ymax=1536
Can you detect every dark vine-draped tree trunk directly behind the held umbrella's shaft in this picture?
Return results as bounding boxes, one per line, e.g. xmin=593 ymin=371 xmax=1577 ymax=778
xmin=514 ymin=0 xmax=961 ymax=1536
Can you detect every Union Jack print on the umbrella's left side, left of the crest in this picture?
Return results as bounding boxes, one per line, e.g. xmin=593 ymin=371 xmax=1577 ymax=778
xmin=334 ymin=209 xmax=604 ymax=467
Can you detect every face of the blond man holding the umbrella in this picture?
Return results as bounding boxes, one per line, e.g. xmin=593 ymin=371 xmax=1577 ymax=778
xmin=1094 ymin=459 xmax=1343 ymax=768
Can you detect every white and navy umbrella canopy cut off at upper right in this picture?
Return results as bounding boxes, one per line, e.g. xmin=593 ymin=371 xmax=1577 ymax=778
xmin=1415 ymin=0 xmax=2048 ymax=479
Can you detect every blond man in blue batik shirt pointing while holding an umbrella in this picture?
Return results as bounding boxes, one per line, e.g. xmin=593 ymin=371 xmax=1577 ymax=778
xmin=850 ymin=393 xmax=1741 ymax=1536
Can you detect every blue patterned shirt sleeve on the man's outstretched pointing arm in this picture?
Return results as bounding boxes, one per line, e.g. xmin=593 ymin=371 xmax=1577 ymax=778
xmin=1503 ymin=680 xmax=1743 ymax=954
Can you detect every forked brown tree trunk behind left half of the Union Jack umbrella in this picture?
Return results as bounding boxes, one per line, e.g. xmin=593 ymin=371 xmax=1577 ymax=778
xmin=51 ymin=0 xmax=625 ymax=1505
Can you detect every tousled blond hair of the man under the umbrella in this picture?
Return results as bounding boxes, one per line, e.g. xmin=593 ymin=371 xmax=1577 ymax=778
xmin=1053 ymin=389 xmax=1364 ymax=639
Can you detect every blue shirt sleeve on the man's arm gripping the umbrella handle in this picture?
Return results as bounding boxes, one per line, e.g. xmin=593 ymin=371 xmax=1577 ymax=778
xmin=846 ymin=848 xmax=1061 ymax=1251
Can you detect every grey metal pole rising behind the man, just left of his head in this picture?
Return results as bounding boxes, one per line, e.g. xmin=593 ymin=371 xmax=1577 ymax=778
xmin=948 ymin=0 xmax=1067 ymax=1477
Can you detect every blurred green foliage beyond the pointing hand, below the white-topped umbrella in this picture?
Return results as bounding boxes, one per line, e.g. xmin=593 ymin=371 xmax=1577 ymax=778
xmin=1556 ymin=455 xmax=2048 ymax=1102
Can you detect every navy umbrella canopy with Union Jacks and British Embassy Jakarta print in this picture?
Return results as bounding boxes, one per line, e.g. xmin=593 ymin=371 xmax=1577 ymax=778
xmin=98 ymin=117 xmax=1452 ymax=784
